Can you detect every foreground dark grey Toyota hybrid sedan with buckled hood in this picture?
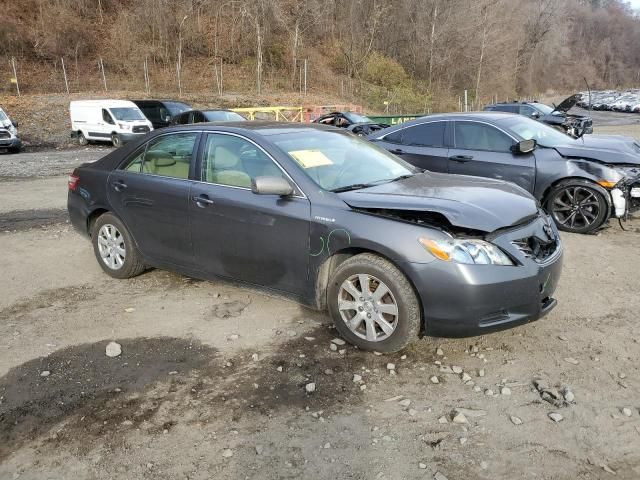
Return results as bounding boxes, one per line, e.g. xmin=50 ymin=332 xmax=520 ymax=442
xmin=68 ymin=122 xmax=562 ymax=352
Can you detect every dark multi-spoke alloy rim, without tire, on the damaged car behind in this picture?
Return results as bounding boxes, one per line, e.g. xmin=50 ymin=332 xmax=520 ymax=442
xmin=552 ymin=186 xmax=600 ymax=229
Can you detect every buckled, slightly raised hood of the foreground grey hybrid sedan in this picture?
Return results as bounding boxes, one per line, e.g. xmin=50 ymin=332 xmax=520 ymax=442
xmin=338 ymin=172 xmax=538 ymax=232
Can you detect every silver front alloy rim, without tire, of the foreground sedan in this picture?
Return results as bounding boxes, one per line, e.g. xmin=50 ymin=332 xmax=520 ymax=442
xmin=338 ymin=273 xmax=398 ymax=342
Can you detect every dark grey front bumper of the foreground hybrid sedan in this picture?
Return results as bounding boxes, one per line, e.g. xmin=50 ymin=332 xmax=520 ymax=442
xmin=407 ymin=215 xmax=563 ymax=337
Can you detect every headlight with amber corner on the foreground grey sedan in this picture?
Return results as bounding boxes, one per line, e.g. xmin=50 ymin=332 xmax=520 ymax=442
xmin=418 ymin=237 xmax=514 ymax=265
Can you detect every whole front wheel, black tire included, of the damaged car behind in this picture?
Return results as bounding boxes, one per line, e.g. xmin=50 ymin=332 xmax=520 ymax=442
xmin=545 ymin=180 xmax=611 ymax=233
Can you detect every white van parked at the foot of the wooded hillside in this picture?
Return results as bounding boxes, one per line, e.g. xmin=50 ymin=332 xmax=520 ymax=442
xmin=69 ymin=100 xmax=153 ymax=147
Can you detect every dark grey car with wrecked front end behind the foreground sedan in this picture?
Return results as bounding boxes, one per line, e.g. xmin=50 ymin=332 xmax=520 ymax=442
xmin=369 ymin=112 xmax=640 ymax=233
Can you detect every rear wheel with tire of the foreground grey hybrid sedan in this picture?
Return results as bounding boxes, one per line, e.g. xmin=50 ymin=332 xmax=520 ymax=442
xmin=91 ymin=213 xmax=145 ymax=278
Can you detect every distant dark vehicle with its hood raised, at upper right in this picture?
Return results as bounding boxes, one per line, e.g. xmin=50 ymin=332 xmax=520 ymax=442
xmin=484 ymin=93 xmax=593 ymax=138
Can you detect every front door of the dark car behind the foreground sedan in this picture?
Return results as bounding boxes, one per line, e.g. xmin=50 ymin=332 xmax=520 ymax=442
xmin=449 ymin=121 xmax=536 ymax=192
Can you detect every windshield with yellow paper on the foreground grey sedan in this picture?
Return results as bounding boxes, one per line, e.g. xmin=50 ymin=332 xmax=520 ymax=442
xmin=269 ymin=131 xmax=418 ymax=190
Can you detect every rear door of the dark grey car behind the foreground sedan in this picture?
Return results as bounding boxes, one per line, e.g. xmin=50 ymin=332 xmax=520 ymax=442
xmin=378 ymin=121 xmax=449 ymax=172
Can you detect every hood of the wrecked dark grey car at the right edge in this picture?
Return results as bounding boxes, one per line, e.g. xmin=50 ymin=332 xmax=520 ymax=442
xmin=555 ymin=135 xmax=640 ymax=165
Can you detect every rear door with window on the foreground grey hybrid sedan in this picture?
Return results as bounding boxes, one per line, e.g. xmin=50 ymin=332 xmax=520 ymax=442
xmin=108 ymin=132 xmax=199 ymax=266
